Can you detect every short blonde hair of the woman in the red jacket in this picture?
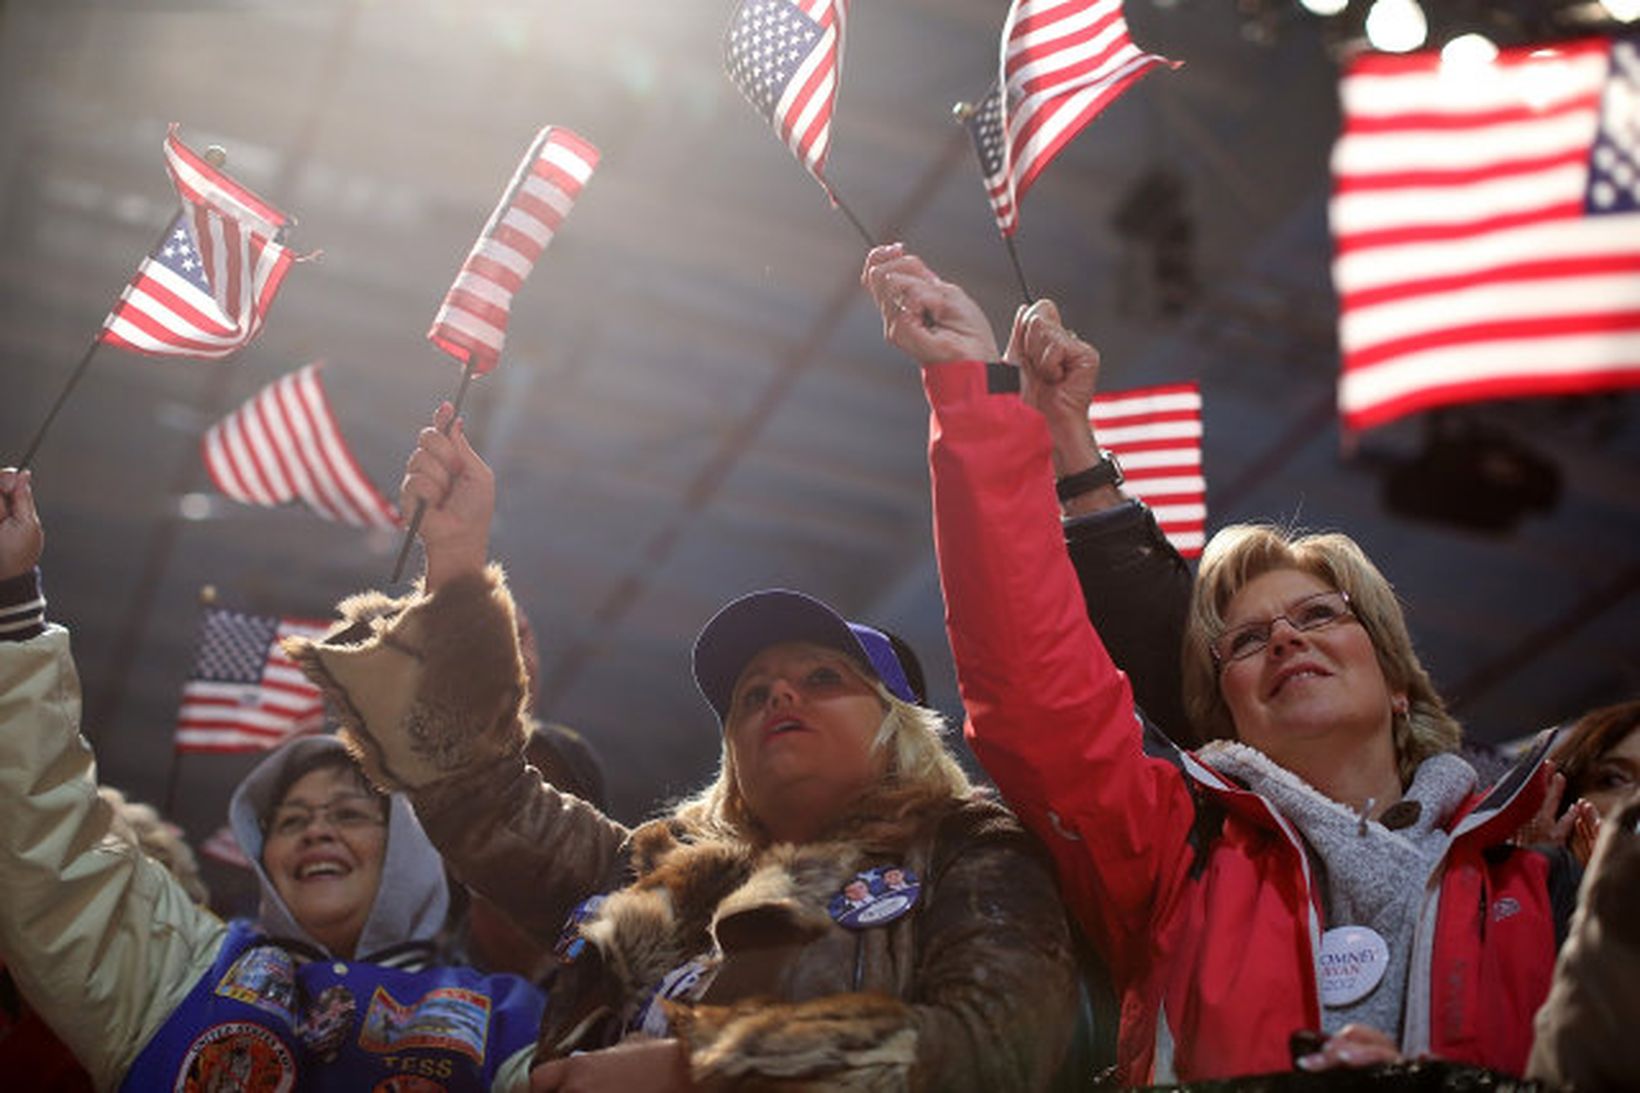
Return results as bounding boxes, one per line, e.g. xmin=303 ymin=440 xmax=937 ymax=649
xmin=1182 ymin=524 xmax=1463 ymax=784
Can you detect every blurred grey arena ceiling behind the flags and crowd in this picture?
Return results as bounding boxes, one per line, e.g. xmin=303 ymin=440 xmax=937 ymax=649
xmin=0 ymin=0 xmax=1640 ymax=912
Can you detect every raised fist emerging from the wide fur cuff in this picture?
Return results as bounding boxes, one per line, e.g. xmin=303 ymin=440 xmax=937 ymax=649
xmin=399 ymin=402 xmax=495 ymax=591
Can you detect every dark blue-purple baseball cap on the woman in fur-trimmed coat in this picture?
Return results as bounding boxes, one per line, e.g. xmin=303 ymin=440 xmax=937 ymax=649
xmin=692 ymin=588 xmax=922 ymax=724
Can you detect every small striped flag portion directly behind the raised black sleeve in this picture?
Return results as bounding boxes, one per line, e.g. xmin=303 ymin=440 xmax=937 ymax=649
xmin=1087 ymin=384 xmax=1207 ymax=558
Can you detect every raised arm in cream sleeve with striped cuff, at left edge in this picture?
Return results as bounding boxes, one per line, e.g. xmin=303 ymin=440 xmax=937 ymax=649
xmin=0 ymin=471 xmax=226 ymax=1088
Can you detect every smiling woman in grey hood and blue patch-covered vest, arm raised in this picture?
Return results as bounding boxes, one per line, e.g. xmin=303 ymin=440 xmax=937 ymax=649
xmin=0 ymin=471 xmax=544 ymax=1091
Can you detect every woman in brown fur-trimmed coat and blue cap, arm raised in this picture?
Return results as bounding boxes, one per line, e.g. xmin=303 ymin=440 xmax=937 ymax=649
xmin=294 ymin=405 xmax=1076 ymax=1090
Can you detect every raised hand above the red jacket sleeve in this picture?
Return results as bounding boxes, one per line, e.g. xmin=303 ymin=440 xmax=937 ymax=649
xmin=859 ymin=243 xmax=997 ymax=364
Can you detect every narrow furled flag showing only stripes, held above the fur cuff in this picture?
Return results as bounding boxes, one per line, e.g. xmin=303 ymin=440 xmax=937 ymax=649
xmin=426 ymin=125 xmax=599 ymax=376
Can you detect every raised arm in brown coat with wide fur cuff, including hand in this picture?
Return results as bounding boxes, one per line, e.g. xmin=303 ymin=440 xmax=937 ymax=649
xmin=290 ymin=413 xmax=626 ymax=945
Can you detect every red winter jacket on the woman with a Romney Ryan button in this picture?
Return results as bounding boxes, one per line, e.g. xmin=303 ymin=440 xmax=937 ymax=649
xmin=923 ymin=361 xmax=1555 ymax=1083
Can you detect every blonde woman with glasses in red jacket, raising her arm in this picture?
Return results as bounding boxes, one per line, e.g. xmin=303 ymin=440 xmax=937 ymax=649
xmin=863 ymin=246 xmax=1573 ymax=1083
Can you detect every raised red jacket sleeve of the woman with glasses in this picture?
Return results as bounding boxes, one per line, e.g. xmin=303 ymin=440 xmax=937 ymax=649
xmin=923 ymin=361 xmax=1194 ymax=970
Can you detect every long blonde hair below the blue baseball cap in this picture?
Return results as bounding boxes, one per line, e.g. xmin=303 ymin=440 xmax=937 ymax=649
xmin=672 ymin=647 xmax=974 ymax=840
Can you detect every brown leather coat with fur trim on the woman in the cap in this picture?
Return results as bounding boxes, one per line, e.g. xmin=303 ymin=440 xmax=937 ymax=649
xmin=292 ymin=568 xmax=1076 ymax=1090
